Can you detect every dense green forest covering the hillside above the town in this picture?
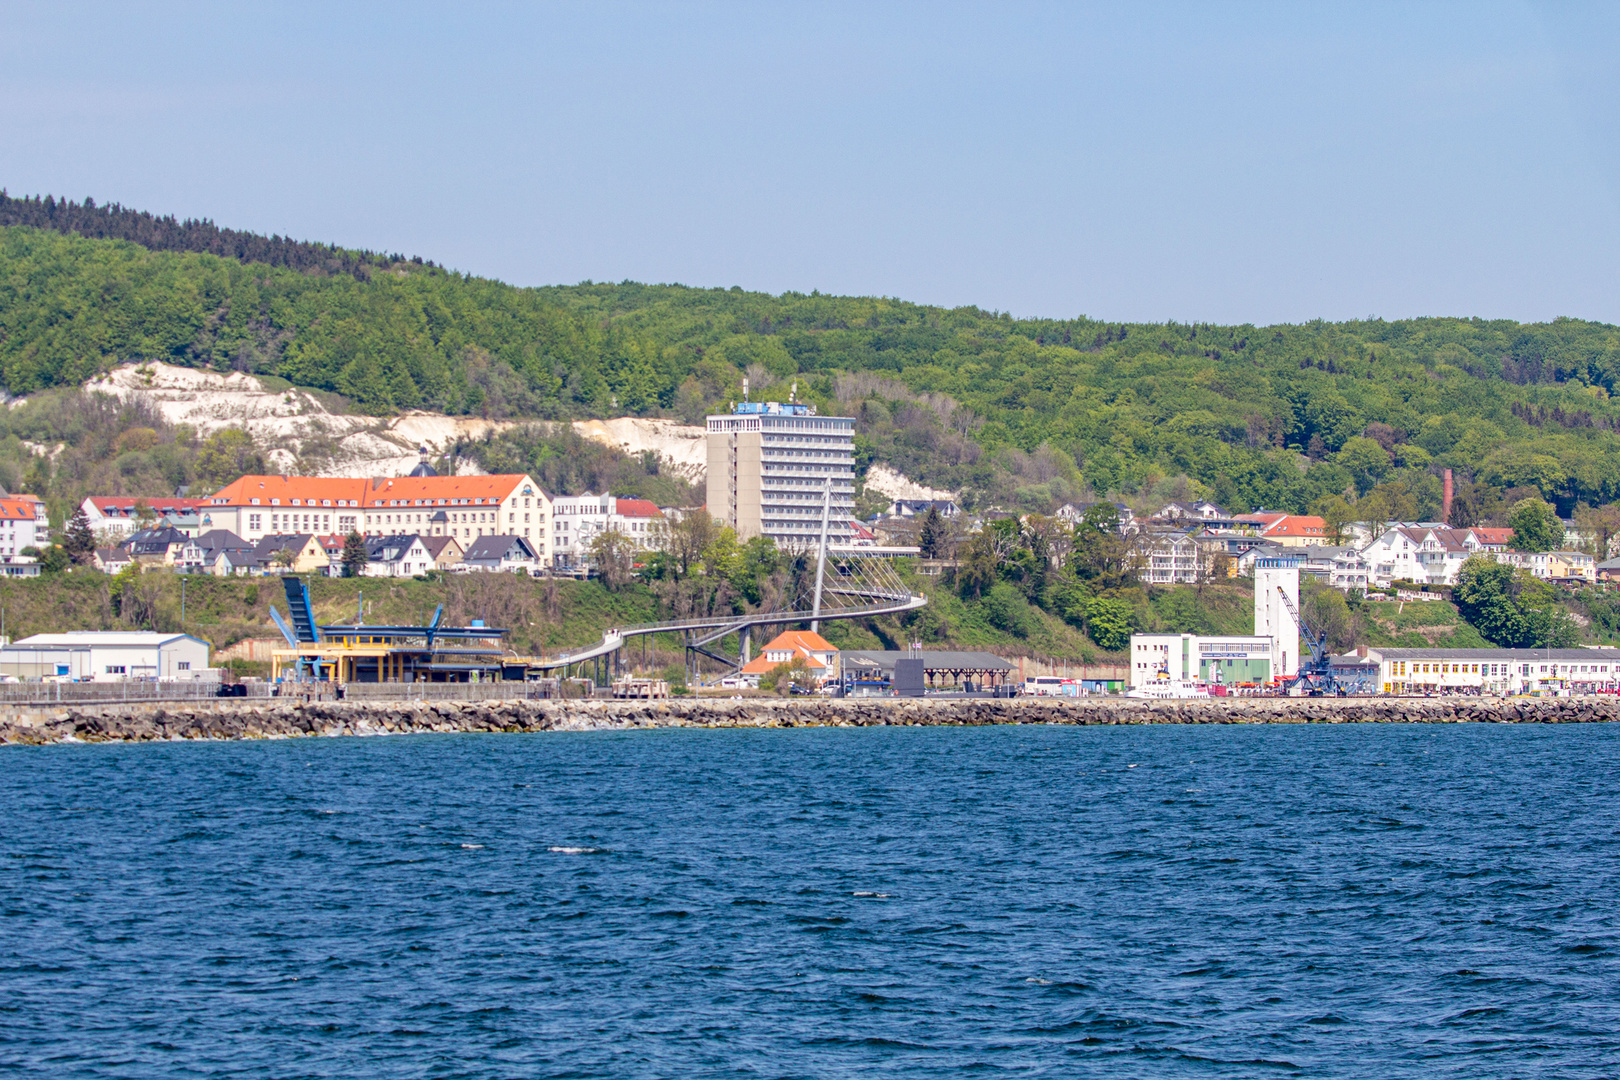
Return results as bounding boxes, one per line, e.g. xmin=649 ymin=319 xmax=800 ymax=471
xmin=0 ymin=199 xmax=1620 ymax=523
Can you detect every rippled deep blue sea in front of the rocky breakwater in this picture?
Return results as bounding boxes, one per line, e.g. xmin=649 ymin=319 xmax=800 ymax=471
xmin=0 ymin=725 xmax=1620 ymax=1080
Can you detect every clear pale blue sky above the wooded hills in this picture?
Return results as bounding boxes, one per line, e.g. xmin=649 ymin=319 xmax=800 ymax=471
xmin=0 ymin=3 xmax=1620 ymax=324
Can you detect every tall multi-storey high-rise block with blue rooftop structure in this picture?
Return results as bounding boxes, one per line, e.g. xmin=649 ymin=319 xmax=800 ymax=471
xmin=708 ymin=402 xmax=855 ymax=547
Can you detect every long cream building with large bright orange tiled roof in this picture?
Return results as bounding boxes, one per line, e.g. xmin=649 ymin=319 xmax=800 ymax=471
xmin=203 ymin=473 xmax=551 ymax=565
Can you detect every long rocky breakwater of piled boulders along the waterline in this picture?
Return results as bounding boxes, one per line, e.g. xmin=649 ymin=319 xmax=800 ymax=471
xmin=0 ymin=698 xmax=1620 ymax=745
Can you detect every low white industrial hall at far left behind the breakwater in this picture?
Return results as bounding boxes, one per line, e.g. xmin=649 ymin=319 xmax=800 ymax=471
xmin=0 ymin=630 xmax=219 ymax=682
